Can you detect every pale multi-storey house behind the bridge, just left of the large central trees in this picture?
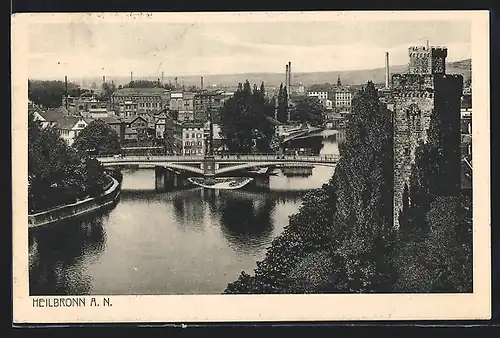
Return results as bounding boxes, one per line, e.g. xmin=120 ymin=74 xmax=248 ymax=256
xmin=173 ymin=121 xmax=206 ymax=156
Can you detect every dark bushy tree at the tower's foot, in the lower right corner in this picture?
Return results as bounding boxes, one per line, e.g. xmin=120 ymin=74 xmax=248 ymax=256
xmin=394 ymin=196 xmax=472 ymax=292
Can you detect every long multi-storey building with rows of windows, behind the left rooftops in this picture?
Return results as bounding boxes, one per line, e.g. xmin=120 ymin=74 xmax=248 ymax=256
xmin=111 ymin=88 xmax=170 ymax=118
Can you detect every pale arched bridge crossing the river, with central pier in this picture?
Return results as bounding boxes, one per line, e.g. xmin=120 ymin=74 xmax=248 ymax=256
xmin=97 ymin=154 xmax=340 ymax=176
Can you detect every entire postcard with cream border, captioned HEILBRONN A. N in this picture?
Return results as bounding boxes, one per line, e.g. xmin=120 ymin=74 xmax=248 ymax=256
xmin=13 ymin=11 xmax=490 ymax=321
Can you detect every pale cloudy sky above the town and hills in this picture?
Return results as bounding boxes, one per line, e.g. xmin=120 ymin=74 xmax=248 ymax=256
xmin=28 ymin=16 xmax=471 ymax=78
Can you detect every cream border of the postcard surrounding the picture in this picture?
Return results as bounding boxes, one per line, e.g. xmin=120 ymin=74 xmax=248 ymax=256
xmin=11 ymin=11 xmax=491 ymax=323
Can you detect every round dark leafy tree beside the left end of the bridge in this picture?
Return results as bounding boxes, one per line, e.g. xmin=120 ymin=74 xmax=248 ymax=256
xmin=73 ymin=119 xmax=121 ymax=155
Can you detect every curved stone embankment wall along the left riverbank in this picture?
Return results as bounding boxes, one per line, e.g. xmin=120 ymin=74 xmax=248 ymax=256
xmin=28 ymin=176 xmax=121 ymax=229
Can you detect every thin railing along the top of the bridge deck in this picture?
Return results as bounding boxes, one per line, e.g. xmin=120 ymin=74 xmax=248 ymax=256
xmin=98 ymin=154 xmax=340 ymax=162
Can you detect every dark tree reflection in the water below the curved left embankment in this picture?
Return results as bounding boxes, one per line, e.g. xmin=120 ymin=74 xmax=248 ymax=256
xmin=29 ymin=215 xmax=106 ymax=295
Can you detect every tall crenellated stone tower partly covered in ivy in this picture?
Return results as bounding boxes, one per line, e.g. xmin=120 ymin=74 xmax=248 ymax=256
xmin=388 ymin=46 xmax=463 ymax=228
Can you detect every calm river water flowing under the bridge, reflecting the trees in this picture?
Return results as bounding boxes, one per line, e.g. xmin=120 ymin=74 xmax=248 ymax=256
xmin=29 ymin=130 xmax=343 ymax=295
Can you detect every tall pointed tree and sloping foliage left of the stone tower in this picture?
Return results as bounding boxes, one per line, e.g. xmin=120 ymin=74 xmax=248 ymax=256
xmin=226 ymin=82 xmax=396 ymax=293
